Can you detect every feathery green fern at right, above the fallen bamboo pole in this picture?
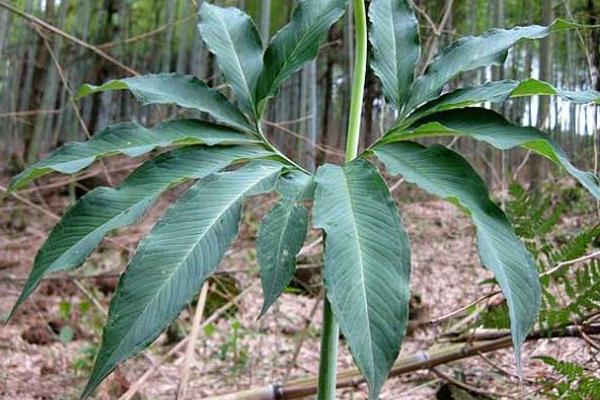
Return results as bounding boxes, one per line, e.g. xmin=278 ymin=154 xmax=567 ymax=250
xmin=477 ymin=183 xmax=600 ymax=330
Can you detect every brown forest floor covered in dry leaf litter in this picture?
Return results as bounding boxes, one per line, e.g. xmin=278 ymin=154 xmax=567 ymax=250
xmin=0 ymin=166 xmax=599 ymax=400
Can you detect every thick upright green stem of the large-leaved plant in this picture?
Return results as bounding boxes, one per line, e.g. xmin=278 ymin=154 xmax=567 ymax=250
xmin=318 ymin=0 xmax=367 ymax=400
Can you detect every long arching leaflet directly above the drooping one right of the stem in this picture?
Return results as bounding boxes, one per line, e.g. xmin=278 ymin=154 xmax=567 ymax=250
xmin=382 ymin=107 xmax=600 ymax=199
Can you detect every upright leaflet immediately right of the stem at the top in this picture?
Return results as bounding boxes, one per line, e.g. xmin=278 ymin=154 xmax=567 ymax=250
xmin=369 ymin=0 xmax=420 ymax=110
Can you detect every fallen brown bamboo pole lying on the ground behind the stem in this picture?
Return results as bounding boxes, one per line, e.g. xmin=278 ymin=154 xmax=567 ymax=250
xmin=205 ymin=324 xmax=600 ymax=400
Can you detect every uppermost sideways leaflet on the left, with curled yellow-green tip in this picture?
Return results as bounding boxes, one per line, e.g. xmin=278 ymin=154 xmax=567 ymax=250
xmin=77 ymin=73 xmax=254 ymax=130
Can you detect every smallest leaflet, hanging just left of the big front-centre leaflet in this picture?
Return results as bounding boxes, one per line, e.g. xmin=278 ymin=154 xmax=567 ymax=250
xmin=256 ymin=171 xmax=313 ymax=315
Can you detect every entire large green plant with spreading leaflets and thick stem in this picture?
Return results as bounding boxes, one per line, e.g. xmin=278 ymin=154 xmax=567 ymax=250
xmin=4 ymin=0 xmax=600 ymax=399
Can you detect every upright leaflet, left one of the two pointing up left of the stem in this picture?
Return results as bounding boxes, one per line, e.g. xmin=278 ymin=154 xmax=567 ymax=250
xmin=198 ymin=2 xmax=263 ymax=112
